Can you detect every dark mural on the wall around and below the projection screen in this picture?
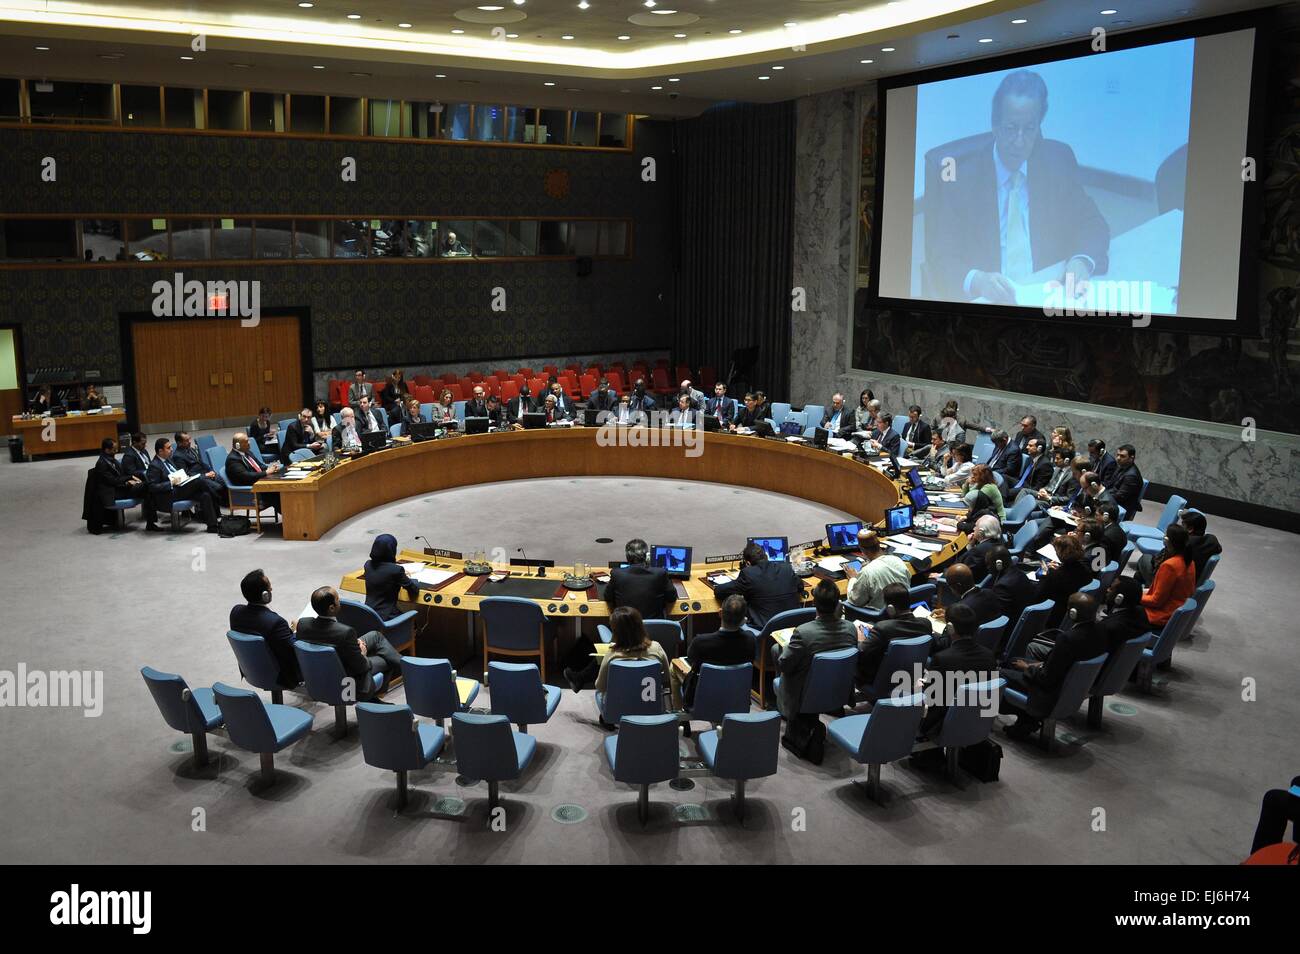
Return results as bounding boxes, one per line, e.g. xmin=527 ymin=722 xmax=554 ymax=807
xmin=853 ymin=9 xmax=1300 ymax=434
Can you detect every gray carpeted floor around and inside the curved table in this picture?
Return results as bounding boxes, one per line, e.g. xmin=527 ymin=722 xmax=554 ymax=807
xmin=0 ymin=434 xmax=1300 ymax=863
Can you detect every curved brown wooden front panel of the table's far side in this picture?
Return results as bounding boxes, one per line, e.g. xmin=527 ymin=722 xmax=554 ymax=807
xmin=256 ymin=428 xmax=900 ymax=539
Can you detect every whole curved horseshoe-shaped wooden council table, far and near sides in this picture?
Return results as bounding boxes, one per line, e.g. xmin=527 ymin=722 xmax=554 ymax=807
xmin=256 ymin=428 xmax=966 ymax=707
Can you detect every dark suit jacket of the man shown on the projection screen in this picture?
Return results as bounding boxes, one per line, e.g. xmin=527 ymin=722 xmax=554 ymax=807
xmin=923 ymin=133 xmax=1110 ymax=302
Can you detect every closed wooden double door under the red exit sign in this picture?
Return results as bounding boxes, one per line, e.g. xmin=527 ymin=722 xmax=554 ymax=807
xmin=131 ymin=315 xmax=304 ymax=429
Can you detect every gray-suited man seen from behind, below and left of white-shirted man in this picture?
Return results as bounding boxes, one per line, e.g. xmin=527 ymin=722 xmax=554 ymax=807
xmin=772 ymin=580 xmax=858 ymax=764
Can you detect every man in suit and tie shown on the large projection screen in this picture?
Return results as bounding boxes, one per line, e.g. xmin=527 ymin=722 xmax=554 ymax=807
xmin=926 ymin=70 xmax=1110 ymax=304
